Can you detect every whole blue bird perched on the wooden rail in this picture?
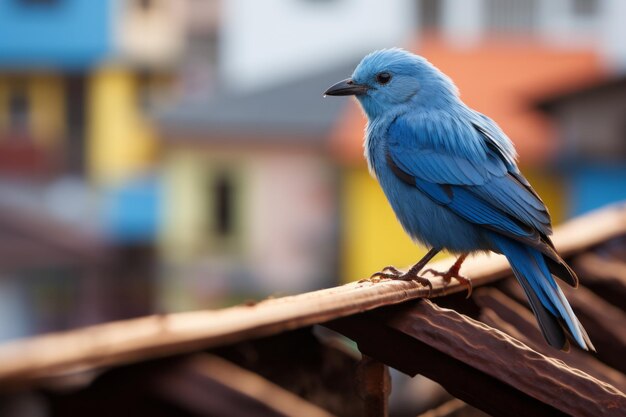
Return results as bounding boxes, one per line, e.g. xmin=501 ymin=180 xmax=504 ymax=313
xmin=325 ymin=48 xmax=595 ymax=351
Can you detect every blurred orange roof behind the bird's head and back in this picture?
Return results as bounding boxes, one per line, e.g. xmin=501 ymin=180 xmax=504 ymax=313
xmin=332 ymin=39 xmax=605 ymax=164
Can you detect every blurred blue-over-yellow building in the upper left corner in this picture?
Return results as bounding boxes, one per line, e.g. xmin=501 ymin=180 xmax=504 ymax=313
xmin=0 ymin=0 xmax=186 ymax=185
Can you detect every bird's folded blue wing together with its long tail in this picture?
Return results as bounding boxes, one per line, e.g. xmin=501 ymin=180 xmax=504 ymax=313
xmin=386 ymin=111 xmax=593 ymax=349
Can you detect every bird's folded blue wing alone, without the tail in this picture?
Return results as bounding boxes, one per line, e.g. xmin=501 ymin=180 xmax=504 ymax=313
xmin=387 ymin=114 xmax=553 ymax=252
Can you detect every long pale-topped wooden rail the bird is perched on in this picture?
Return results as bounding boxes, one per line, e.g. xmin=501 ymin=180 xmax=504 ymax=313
xmin=0 ymin=206 xmax=626 ymax=388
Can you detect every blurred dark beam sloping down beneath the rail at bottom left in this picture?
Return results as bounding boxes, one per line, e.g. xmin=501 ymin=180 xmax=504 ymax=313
xmin=43 ymin=353 xmax=334 ymax=417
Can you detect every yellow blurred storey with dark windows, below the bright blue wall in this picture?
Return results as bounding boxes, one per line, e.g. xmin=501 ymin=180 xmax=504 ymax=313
xmin=0 ymin=67 xmax=166 ymax=183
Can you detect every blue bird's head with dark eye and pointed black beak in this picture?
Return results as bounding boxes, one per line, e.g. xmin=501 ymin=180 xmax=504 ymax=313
xmin=324 ymin=48 xmax=458 ymax=120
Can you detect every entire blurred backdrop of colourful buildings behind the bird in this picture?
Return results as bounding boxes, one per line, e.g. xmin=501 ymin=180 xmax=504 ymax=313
xmin=0 ymin=0 xmax=626 ymax=341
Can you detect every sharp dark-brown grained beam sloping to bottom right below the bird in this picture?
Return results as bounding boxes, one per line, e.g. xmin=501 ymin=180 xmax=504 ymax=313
xmin=328 ymin=300 xmax=626 ymax=417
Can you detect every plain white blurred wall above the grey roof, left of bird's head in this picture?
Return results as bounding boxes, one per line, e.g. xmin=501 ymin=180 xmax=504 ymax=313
xmin=218 ymin=0 xmax=416 ymax=91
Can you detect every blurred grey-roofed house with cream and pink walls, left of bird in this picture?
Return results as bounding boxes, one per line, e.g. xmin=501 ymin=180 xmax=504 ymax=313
xmin=155 ymin=66 xmax=350 ymax=309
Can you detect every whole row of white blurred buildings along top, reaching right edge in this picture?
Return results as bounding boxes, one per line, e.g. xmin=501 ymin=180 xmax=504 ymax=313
xmin=205 ymin=0 xmax=626 ymax=91
